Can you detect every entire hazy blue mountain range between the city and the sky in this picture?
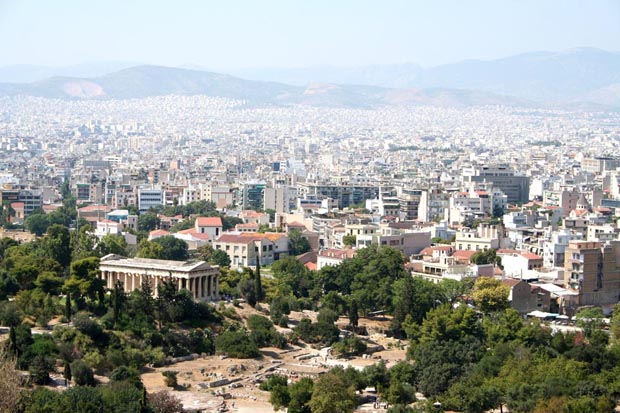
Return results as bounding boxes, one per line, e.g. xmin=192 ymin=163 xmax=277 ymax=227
xmin=0 ymin=48 xmax=620 ymax=110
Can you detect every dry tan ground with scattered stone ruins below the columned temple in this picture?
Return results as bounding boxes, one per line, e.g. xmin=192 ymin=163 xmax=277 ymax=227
xmin=142 ymin=305 xmax=405 ymax=413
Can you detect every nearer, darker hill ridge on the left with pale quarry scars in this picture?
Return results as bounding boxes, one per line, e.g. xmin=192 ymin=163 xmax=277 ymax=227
xmin=0 ymin=66 xmax=528 ymax=108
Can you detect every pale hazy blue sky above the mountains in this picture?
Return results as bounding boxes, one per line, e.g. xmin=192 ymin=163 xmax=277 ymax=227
xmin=0 ymin=0 xmax=620 ymax=69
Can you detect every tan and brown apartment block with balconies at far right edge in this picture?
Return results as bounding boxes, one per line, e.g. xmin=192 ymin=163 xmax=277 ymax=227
xmin=564 ymin=241 xmax=620 ymax=306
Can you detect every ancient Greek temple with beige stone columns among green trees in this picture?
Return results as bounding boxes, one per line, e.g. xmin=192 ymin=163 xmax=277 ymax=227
xmin=99 ymin=254 xmax=220 ymax=301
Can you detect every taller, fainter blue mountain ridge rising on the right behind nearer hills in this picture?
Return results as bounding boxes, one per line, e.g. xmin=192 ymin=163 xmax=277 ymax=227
xmin=233 ymin=48 xmax=620 ymax=107
